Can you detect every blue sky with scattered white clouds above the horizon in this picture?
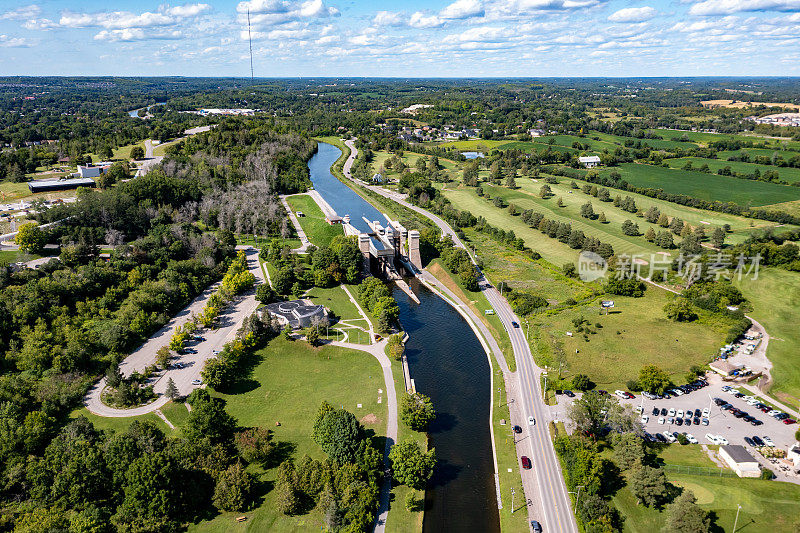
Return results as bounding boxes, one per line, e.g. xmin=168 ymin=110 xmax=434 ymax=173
xmin=0 ymin=0 xmax=800 ymax=77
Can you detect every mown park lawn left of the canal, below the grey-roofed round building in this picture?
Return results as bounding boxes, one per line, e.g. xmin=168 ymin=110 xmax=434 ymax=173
xmin=189 ymin=337 xmax=392 ymax=532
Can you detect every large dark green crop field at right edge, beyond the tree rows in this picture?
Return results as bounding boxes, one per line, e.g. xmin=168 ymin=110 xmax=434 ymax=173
xmin=604 ymin=163 xmax=800 ymax=207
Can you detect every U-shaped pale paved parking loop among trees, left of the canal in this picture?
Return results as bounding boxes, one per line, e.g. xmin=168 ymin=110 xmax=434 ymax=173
xmin=84 ymin=247 xmax=264 ymax=417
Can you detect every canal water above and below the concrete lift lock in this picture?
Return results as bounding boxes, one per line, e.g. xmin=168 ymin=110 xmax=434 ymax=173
xmin=308 ymin=143 xmax=500 ymax=533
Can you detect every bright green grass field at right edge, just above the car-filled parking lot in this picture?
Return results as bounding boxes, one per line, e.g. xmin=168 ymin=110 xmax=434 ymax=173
xmin=736 ymin=267 xmax=800 ymax=408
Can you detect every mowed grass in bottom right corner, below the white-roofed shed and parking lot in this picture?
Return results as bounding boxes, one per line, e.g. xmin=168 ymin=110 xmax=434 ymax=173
xmin=613 ymin=444 xmax=800 ymax=533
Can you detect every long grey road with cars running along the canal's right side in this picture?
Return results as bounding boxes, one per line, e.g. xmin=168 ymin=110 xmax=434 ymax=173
xmin=343 ymin=140 xmax=578 ymax=533
